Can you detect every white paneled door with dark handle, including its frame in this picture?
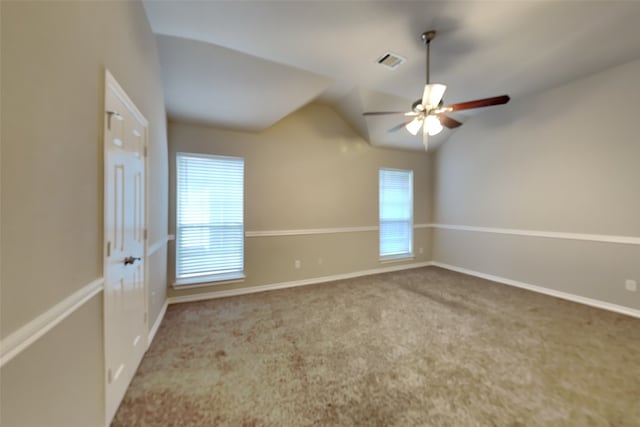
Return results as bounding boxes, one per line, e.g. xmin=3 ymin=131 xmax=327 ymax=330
xmin=104 ymin=71 xmax=148 ymax=424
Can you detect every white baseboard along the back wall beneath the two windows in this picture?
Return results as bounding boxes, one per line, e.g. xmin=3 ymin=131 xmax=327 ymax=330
xmin=168 ymin=262 xmax=431 ymax=304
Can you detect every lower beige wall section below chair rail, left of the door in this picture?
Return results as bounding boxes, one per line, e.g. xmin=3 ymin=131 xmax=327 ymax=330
xmin=0 ymin=294 xmax=104 ymax=427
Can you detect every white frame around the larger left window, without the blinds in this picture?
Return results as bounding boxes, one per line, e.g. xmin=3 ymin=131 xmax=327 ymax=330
xmin=173 ymin=152 xmax=246 ymax=288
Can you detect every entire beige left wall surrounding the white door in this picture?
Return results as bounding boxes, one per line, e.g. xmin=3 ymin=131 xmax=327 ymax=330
xmin=0 ymin=1 xmax=168 ymax=427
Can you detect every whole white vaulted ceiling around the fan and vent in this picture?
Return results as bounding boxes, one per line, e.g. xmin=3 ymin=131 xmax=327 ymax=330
xmin=144 ymin=0 xmax=640 ymax=149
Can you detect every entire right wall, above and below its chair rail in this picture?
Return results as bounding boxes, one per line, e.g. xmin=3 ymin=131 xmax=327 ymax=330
xmin=433 ymin=56 xmax=640 ymax=309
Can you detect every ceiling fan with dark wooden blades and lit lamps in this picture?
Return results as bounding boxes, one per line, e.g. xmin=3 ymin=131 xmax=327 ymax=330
xmin=363 ymin=31 xmax=510 ymax=150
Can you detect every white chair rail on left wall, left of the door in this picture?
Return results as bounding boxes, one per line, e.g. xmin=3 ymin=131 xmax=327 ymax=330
xmin=0 ymin=277 xmax=104 ymax=366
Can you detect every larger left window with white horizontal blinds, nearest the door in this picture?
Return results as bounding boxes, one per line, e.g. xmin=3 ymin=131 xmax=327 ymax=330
xmin=176 ymin=153 xmax=244 ymax=285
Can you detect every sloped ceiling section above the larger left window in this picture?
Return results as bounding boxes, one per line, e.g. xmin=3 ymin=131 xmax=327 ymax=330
xmin=157 ymin=35 xmax=333 ymax=132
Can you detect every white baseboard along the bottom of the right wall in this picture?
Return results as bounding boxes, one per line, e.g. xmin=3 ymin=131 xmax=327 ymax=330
xmin=431 ymin=261 xmax=640 ymax=319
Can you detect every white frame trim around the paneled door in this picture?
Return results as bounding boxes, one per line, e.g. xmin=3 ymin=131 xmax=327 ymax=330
xmin=102 ymin=69 xmax=149 ymax=426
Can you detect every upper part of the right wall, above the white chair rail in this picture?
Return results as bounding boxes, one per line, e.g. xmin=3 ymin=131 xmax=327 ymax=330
xmin=434 ymin=56 xmax=640 ymax=236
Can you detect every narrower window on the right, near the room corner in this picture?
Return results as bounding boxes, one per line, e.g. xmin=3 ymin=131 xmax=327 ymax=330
xmin=379 ymin=169 xmax=413 ymax=260
